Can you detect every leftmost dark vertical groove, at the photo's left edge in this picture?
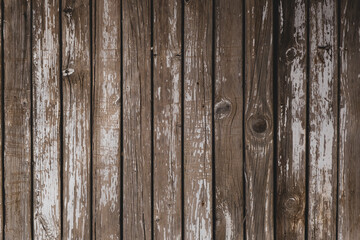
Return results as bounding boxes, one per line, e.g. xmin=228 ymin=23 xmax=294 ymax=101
xmin=1 ymin=0 xmax=6 ymax=240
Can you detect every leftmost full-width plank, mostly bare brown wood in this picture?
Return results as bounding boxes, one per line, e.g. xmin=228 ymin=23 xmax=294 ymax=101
xmin=4 ymin=1 xmax=32 ymax=239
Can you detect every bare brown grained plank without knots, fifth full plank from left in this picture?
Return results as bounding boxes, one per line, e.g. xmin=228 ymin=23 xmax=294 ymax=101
xmin=122 ymin=0 xmax=152 ymax=239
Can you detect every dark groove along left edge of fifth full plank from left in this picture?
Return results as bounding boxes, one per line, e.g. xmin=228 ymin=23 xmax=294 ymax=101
xmin=120 ymin=0 xmax=124 ymax=239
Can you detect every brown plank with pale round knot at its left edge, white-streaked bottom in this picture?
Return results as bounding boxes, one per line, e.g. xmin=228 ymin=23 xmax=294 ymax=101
xmin=214 ymin=0 xmax=244 ymax=239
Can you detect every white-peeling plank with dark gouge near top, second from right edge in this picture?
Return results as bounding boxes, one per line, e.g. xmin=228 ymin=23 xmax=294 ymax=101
xmin=308 ymin=0 xmax=338 ymax=239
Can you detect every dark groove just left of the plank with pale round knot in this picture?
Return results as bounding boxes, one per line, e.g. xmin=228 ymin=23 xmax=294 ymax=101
xmin=211 ymin=0 xmax=216 ymax=239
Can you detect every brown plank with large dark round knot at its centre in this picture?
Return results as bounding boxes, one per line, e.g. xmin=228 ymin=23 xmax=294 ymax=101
xmin=244 ymin=0 xmax=274 ymax=239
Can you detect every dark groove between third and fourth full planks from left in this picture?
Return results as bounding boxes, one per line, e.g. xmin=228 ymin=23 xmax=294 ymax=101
xmin=89 ymin=0 xmax=94 ymax=240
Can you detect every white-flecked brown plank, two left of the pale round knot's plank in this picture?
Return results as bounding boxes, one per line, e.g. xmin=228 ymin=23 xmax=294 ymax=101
xmin=153 ymin=0 xmax=182 ymax=239
